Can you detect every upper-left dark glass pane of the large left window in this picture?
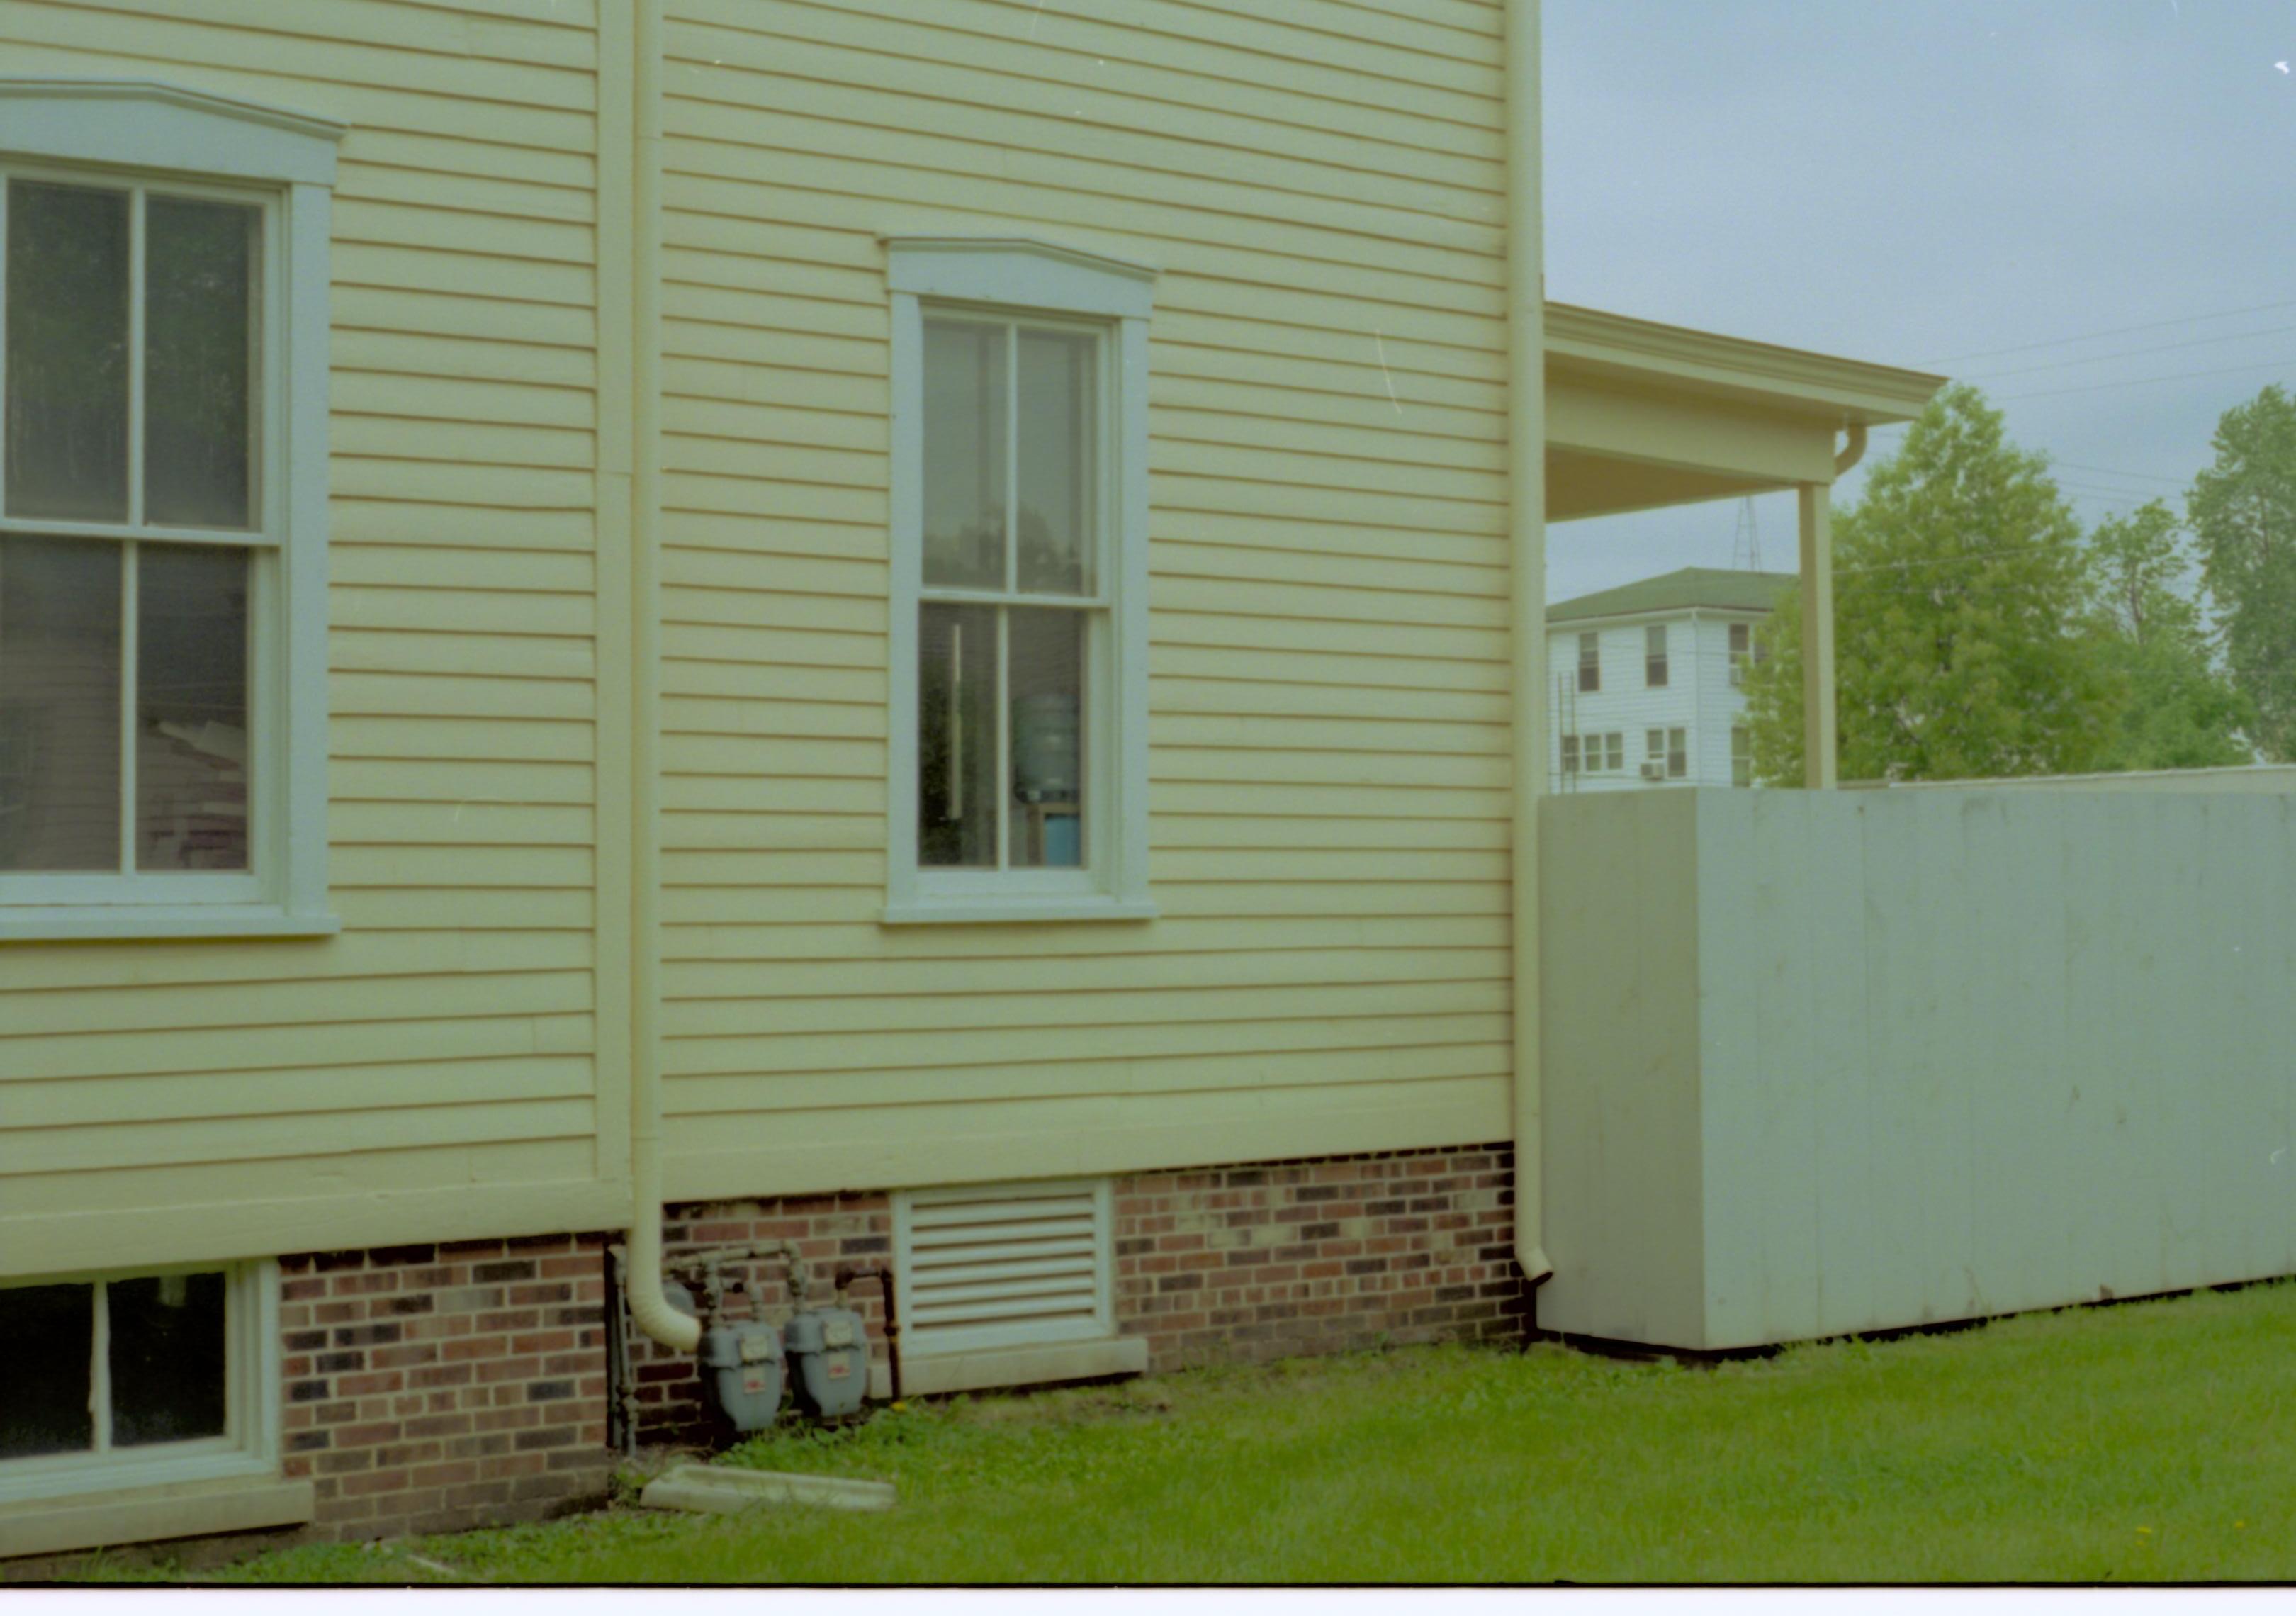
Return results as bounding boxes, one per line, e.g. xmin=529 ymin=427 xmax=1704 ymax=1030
xmin=7 ymin=179 xmax=128 ymax=521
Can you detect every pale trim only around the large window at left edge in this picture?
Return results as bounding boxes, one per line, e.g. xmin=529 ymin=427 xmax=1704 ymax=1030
xmin=0 ymin=78 xmax=344 ymax=941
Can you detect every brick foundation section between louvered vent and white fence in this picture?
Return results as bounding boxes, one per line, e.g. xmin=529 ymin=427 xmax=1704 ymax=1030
xmin=1116 ymin=1145 xmax=1527 ymax=1370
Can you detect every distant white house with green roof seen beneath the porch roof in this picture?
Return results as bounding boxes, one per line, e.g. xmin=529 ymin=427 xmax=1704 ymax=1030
xmin=1548 ymin=567 xmax=1796 ymax=792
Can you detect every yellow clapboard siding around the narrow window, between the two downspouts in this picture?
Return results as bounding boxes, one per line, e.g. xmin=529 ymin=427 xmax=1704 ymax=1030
xmin=663 ymin=0 xmax=1509 ymax=1199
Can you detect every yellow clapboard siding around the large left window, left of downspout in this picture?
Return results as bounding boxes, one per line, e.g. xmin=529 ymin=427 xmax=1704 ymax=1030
xmin=0 ymin=0 xmax=611 ymax=1272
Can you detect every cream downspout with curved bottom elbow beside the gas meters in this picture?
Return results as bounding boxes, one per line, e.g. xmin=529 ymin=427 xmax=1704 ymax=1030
xmin=609 ymin=0 xmax=702 ymax=1352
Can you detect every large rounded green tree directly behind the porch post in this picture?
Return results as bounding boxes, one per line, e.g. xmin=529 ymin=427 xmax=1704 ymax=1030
xmin=1748 ymin=386 xmax=2128 ymax=785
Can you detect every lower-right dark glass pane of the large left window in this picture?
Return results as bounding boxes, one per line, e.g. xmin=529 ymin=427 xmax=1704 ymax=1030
xmin=135 ymin=544 xmax=250 ymax=870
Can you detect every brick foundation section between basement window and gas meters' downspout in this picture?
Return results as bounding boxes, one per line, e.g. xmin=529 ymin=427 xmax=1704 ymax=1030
xmin=280 ymin=1235 xmax=613 ymax=1538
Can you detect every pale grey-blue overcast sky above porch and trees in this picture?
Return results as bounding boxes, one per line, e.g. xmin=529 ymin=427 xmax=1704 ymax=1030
xmin=1543 ymin=0 xmax=2296 ymax=602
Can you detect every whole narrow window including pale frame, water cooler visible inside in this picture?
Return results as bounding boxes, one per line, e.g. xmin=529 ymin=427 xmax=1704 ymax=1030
xmin=887 ymin=239 xmax=1148 ymax=923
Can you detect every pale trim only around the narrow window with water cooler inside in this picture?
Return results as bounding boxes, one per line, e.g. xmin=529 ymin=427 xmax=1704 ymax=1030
xmin=882 ymin=237 xmax=1155 ymax=925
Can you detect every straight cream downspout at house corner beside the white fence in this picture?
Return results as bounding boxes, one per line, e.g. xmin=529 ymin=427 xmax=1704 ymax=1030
xmin=1504 ymin=0 xmax=1554 ymax=1286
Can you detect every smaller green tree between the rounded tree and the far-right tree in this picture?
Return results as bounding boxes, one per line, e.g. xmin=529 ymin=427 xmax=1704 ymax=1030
xmin=2089 ymin=500 xmax=2257 ymax=769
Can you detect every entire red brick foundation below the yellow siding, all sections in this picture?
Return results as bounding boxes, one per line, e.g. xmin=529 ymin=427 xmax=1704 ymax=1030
xmin=260 ymin=1145 xmax=1524 ymax=1538
